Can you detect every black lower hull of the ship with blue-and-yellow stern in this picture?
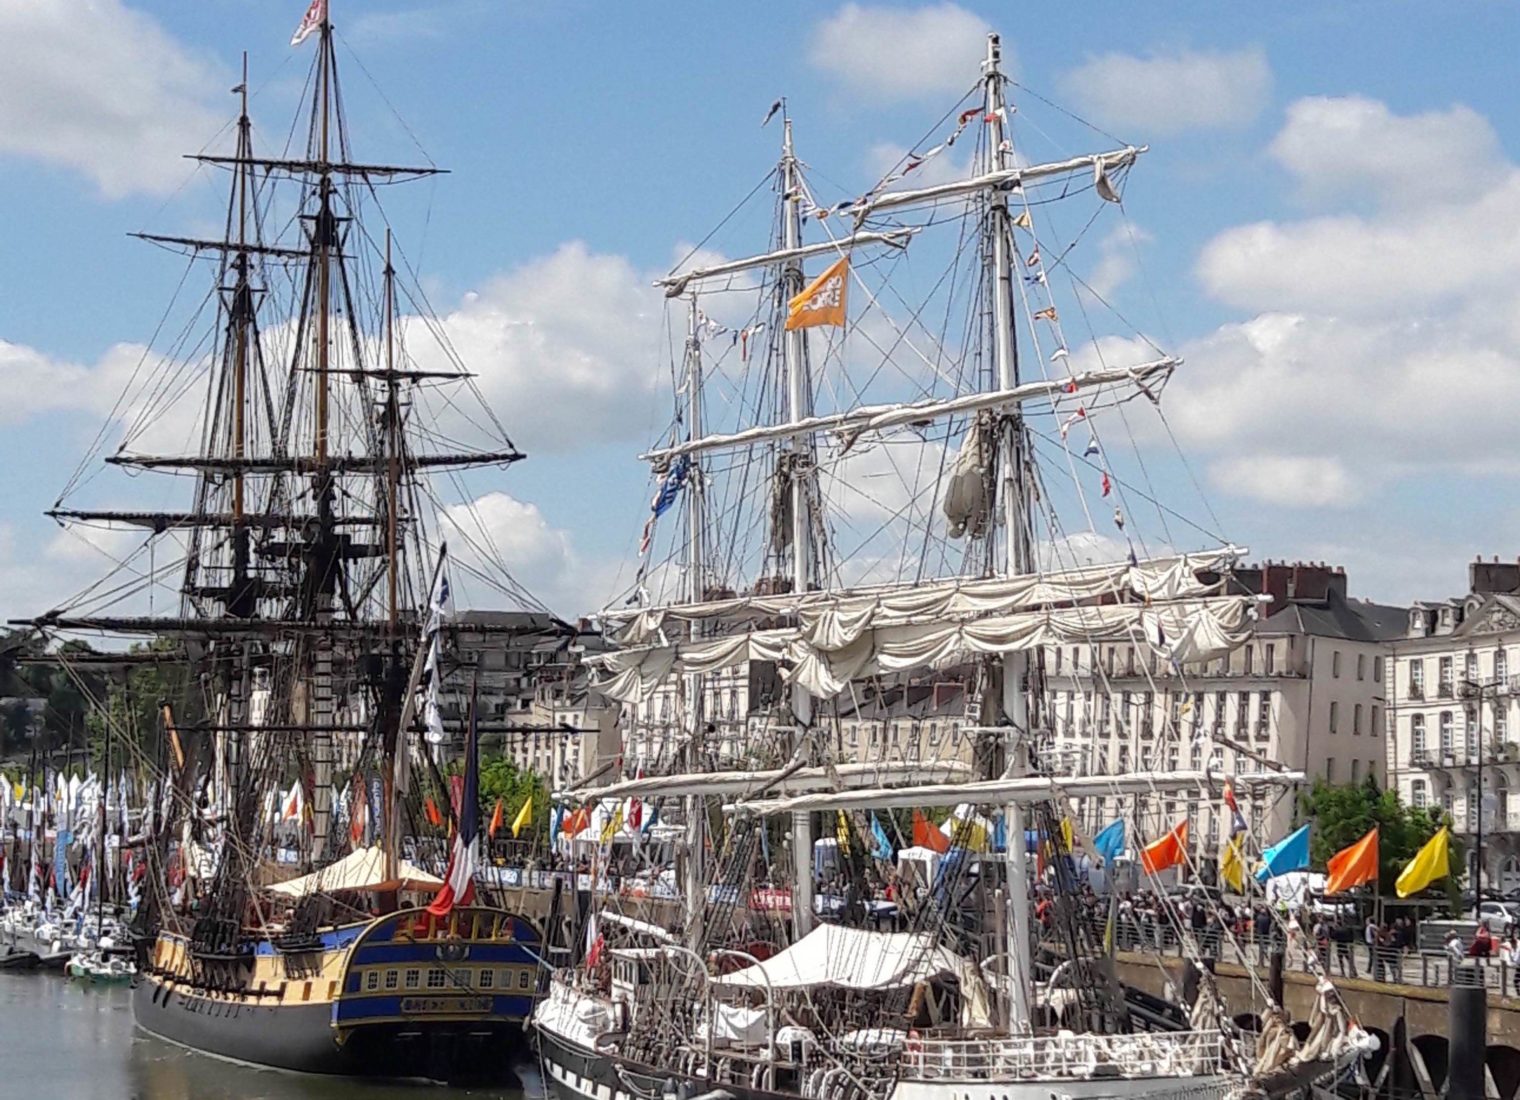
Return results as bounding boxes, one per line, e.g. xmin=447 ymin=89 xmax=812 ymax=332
xmin=132 ymin=978 xmax=521 ymax=1083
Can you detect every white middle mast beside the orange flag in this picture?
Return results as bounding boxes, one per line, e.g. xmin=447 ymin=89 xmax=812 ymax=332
xmin=780 ymin=117 xmax=813 ymax=939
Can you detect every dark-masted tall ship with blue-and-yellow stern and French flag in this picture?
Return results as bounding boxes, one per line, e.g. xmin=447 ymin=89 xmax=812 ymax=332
xmin=22 ymin=0 xmax=541 ymax=1080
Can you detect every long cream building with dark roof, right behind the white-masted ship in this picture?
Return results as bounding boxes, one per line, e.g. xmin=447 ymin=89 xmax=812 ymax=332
xmin=1044 ymin=562 xmax=1404 ymax=854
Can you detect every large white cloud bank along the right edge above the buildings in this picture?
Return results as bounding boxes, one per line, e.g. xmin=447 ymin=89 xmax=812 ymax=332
xmin=1167 ymin=99 xmax=1520 ymax=516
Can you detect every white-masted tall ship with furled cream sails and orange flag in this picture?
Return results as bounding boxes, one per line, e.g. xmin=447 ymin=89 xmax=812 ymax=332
xmin=532 ymin=36 xmax=1365 ymax=1100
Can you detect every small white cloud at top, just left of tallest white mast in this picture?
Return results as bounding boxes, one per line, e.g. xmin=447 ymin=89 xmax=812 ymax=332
xmin=807 ymin=3 xmax=1012 ymax=99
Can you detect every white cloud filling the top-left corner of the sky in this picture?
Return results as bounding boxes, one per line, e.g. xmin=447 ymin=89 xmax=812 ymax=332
xmin=0 ymin=0 xmax=228 ymax=198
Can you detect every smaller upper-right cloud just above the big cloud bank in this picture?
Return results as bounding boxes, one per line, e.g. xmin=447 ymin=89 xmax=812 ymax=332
xmin=1271 ymin=96 xmax=1505 ymax=205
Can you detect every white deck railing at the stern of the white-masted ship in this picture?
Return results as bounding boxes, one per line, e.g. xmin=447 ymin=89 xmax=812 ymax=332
xmin=901 ymin=1030 xmax=1222 ymax=1080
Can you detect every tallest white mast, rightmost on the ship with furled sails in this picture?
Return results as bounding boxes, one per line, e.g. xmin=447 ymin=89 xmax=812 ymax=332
xmin=983 ymin=35 xmax=1035 ymax=1032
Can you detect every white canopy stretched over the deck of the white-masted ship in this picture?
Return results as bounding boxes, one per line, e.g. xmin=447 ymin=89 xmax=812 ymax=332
xmin=713 ymin=924 xmax=977 ymax=992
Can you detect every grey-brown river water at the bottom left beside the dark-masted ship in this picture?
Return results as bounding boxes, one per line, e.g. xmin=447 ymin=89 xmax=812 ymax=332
xmin=0 ymin=972 xmax=543 ymax=1100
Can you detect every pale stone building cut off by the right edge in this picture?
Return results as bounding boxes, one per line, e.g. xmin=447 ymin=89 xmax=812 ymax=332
xmin=1388 ymin=561 xmax=1520 ymax=890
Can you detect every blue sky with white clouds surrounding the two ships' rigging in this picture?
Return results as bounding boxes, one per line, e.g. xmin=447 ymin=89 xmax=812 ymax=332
xmin=0 ymin=0 xmax=1520 ymax=617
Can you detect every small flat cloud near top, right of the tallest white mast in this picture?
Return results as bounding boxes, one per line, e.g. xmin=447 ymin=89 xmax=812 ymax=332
xmin=1061 ymin=47 xmax=1272 ymax=134
